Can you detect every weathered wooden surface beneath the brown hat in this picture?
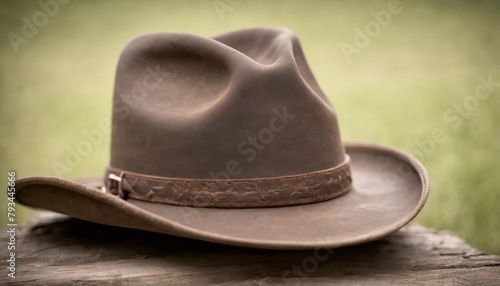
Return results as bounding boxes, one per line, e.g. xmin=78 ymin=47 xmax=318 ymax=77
xmin=0 ymin=214 xmax=500 ymax=285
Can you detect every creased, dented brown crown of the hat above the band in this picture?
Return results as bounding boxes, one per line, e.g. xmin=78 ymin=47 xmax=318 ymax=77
xmin=110 ymin=29 xmax=345 ymax=179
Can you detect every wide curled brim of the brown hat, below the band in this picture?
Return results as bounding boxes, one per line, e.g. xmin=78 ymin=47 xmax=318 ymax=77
xmin=16 ymin=143 xmax=429 ymax=249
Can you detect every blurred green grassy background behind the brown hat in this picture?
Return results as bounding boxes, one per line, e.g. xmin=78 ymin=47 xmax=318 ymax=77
xmin=0 ymin=0 xmax=500 ymax=254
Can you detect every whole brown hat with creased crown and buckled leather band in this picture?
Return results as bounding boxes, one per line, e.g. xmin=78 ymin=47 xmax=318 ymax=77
xmin=16 ymin=28 xmax=429 ymax=249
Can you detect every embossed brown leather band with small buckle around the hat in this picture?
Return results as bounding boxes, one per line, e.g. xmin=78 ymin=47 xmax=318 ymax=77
xmin=105 ymin=155 xmax=352 ymax=208
